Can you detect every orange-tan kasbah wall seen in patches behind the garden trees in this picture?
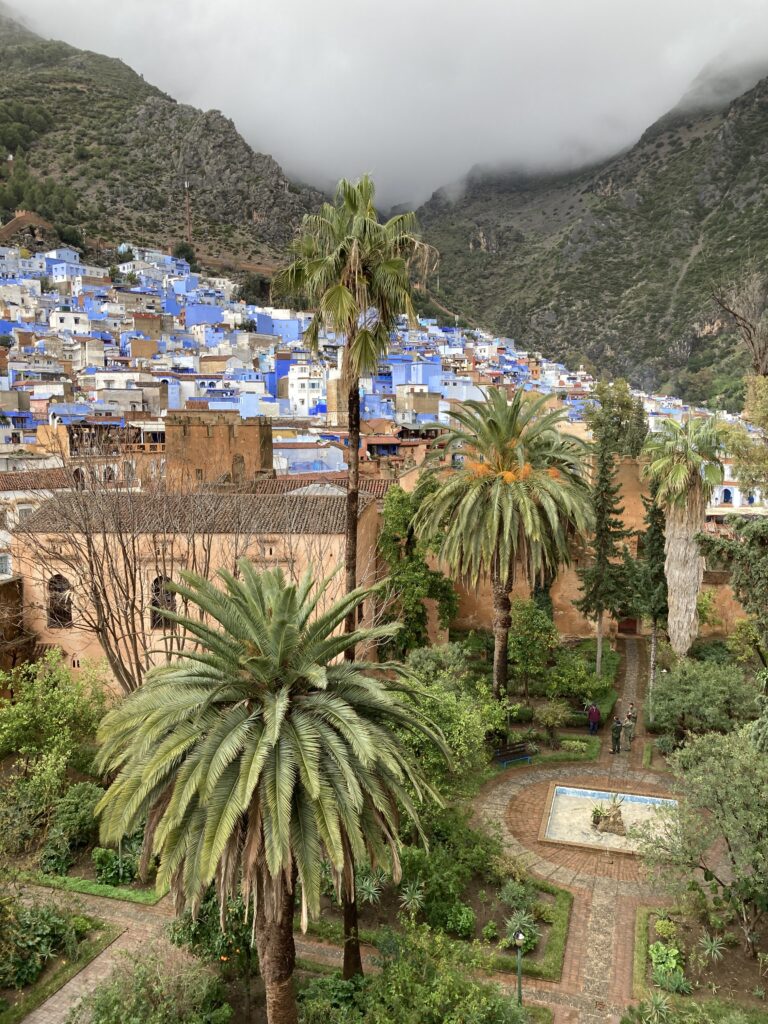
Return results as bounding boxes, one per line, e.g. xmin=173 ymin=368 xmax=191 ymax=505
xmin=436 ymin=458 xmax=745 ymax=637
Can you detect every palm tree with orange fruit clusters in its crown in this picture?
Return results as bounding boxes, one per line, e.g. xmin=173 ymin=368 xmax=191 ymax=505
xmin=415 ymin=388 xmax=591 ymax=696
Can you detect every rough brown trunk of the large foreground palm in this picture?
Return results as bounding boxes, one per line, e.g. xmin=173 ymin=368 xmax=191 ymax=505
xmin=256 ymin=886 xmax=299 ymax=1024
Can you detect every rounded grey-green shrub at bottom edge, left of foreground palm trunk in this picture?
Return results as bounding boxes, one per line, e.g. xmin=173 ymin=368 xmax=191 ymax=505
xmin=67 ymin=949 xmax=232 ymax=1024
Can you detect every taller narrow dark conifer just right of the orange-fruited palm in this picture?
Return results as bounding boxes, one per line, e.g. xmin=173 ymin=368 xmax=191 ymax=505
xmin=575 ymin=431 xmax=629 ymax=676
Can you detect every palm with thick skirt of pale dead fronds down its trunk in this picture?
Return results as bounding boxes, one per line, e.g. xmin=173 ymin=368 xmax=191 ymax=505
xmin=643 ymin=417 xmax=723 ymax=657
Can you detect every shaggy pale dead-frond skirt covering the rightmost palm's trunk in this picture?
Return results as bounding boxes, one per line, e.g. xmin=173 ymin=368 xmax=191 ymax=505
xmin=664 ymin=487 xmax=706 ymax=657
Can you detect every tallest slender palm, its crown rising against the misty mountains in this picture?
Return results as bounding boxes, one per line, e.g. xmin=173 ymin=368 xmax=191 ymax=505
xmin=274 ymin=175 xmax=436 ymax=638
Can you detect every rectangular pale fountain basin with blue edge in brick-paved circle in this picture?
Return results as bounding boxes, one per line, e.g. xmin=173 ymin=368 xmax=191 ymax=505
xmin=539 ymin=783 xmax=677 ymax=854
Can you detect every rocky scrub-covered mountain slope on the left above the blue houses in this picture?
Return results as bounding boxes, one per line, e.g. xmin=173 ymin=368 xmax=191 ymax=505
xmin=0 ymin=8 xmax=322 ymax=262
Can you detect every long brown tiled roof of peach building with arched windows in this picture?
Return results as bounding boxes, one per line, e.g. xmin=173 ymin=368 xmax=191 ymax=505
xmin=24 ymin=492 xmax=373 ymax=535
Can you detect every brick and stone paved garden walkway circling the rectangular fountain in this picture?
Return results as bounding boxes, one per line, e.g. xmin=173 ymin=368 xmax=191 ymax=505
xmin=25 ymin=639 xmax=664 ymax=1024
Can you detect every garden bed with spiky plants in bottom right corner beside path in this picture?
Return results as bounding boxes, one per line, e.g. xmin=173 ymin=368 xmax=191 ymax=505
xmin=633 ymin=907 xmax=768 ymax=1003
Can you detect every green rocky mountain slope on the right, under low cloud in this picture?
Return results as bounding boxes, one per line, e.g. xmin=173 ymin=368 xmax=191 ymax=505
xmin=419 ymin=66 xmax=768 ymax=403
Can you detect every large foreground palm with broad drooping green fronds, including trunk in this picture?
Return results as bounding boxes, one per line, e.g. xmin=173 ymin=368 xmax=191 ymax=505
xmin=98 ymin=559 xmax=444 ymax=1024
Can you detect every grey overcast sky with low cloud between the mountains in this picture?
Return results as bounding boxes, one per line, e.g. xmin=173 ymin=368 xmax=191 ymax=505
xmin=9 ymin=0 xmax=768 ymax=204
